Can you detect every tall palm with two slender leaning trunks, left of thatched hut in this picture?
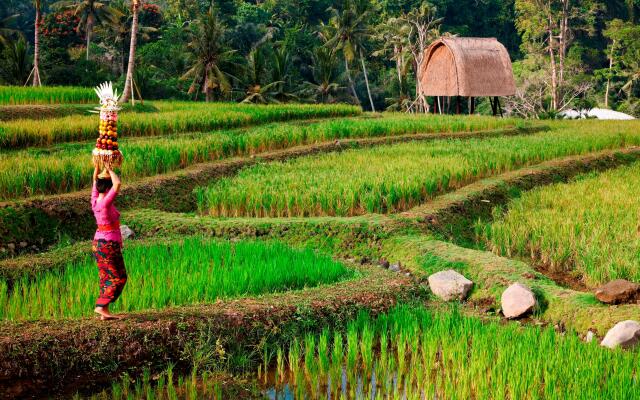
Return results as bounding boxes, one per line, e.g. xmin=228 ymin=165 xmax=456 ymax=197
xmin=326 ymin=0 xmax=375 ymax=111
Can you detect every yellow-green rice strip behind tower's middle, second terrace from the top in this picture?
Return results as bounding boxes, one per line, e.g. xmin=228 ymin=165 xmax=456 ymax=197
xmin=0 ymin=102 xmax=361 ymax=149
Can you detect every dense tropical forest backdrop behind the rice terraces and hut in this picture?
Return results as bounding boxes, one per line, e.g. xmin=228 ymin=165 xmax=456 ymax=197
xmin=0 ymin=0 xmax=640 ymax=117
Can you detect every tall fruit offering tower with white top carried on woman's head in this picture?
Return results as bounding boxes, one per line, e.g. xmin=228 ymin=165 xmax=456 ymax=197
xmin=93 ymin=82 xmax=122 ymax=176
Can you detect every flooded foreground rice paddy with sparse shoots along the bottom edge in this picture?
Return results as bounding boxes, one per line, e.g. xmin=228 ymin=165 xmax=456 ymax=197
xmin=82 ymin=306 xmax=640 ymax=400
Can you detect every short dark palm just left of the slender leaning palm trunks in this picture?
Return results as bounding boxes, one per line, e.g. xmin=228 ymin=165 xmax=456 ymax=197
xmin=305 ymin=46 xmax=344 ymax=103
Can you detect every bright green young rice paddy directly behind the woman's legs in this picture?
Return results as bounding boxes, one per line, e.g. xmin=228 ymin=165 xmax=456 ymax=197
xmin=0 ymin=237 xmax=354 ymax=320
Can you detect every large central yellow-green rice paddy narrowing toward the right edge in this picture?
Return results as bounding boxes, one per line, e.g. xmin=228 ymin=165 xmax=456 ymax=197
xmin=195 ymin=121 xmax=640 ymax=217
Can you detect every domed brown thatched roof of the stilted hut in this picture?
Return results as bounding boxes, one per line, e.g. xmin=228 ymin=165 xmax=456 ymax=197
xmin=420 ymin=37 xmax=516 ymax=97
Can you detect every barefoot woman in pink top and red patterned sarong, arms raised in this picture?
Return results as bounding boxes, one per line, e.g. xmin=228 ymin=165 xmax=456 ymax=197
xmin=91 ymin=167 xmax=127 ymax=321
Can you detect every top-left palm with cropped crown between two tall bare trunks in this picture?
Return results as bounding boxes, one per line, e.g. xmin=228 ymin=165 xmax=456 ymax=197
xmin=53 ymin=0 xmax=120 ymax=60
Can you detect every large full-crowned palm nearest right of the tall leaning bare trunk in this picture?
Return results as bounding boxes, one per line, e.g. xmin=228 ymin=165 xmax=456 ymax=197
xmin=182 ymin=7 xmax=235 ymax=101
